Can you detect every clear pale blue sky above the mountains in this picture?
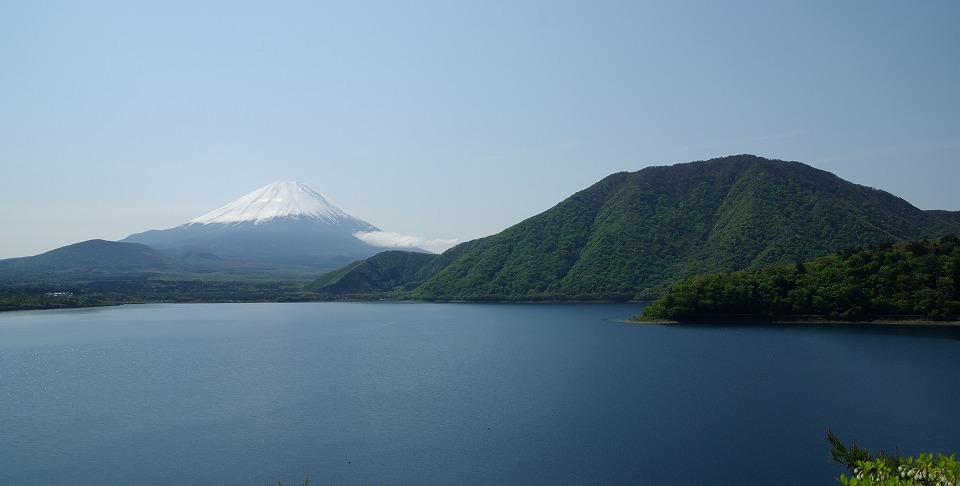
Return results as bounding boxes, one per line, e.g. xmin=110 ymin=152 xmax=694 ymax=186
xmin=0 ymin=0 xmax=960 ymax=258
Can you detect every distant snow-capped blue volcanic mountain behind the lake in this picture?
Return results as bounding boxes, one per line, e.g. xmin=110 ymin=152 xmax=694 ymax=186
xmin=120 ymin=182 xmax=409 ymax=274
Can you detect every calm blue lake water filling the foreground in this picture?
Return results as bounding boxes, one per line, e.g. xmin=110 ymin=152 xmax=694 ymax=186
xmin=0 ymin=303 xmax=960 ymax=485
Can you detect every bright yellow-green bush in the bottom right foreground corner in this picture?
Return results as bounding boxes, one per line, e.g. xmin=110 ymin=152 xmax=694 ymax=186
xmin=827 ymin=430 xmax=960 ymax=486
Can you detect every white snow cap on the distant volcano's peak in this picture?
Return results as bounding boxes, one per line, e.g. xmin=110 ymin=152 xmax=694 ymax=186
xmin=186 ymin=182 xmax=375 ymax=229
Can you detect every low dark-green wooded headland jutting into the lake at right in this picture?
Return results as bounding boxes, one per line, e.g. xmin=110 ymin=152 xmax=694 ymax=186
xmin=643 ymin=236 xmax=960 ymax=320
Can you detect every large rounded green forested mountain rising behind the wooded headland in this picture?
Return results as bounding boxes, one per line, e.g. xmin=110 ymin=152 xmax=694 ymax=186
xmin=310 ymin=155 xmax=960 ymax=301
